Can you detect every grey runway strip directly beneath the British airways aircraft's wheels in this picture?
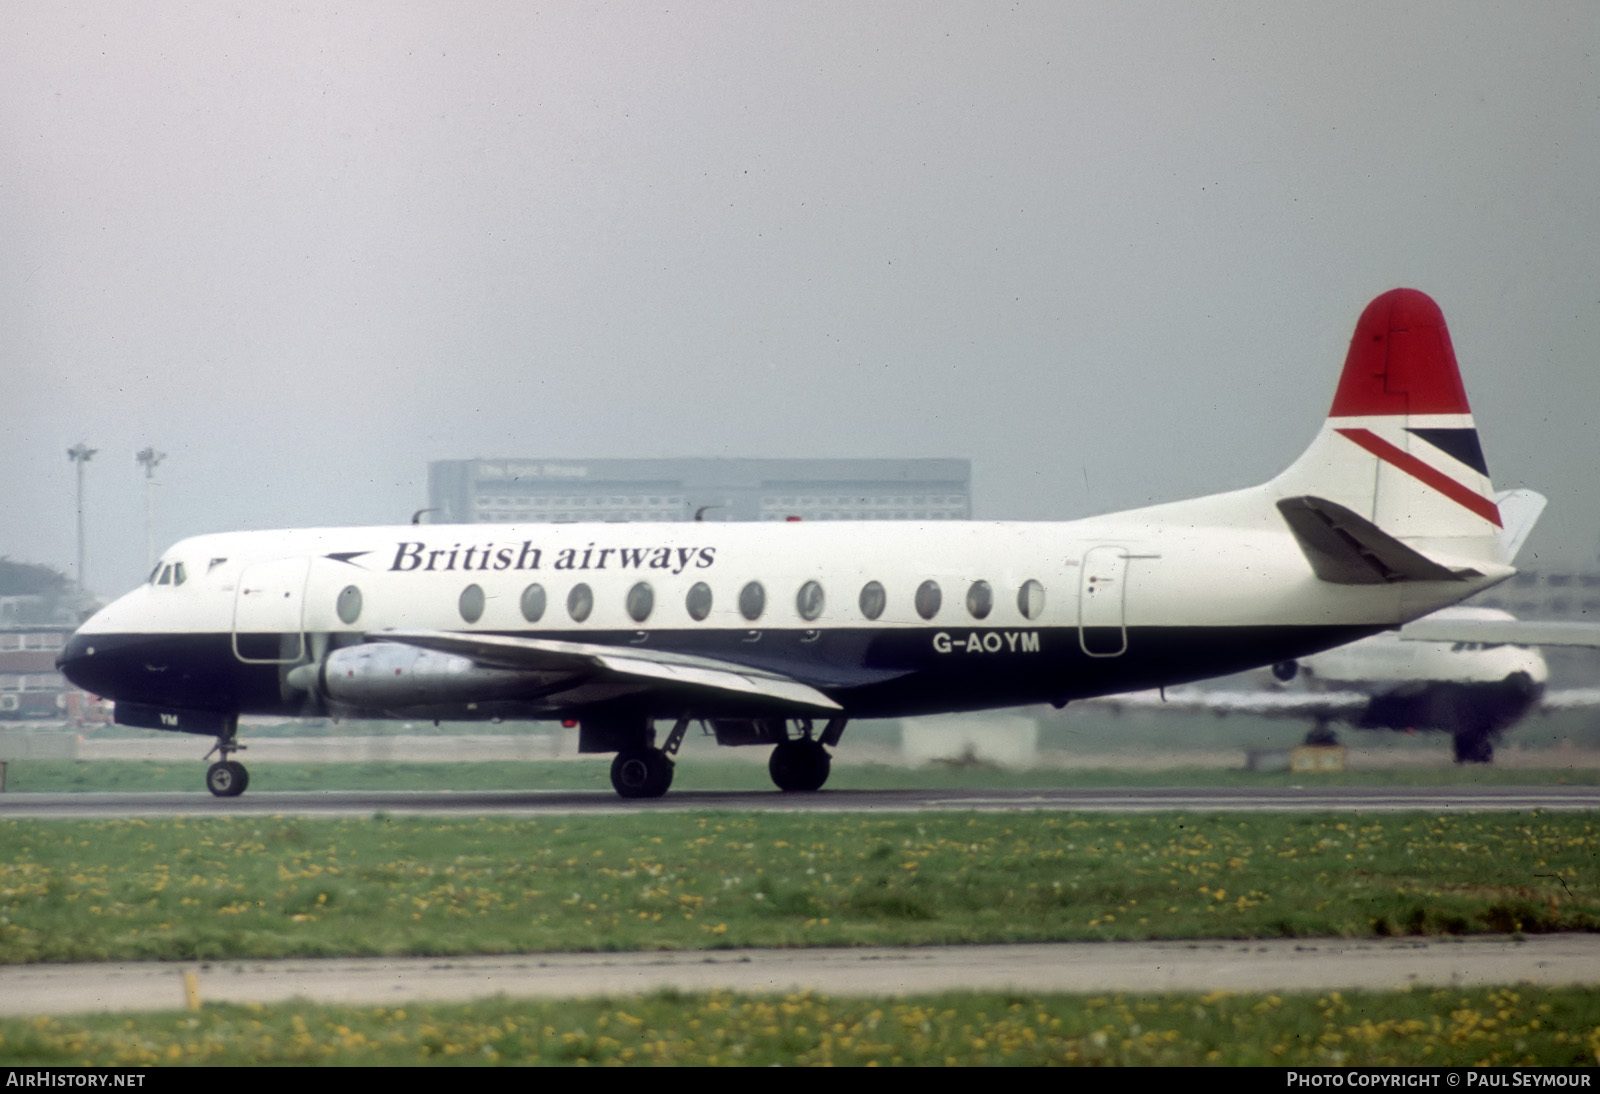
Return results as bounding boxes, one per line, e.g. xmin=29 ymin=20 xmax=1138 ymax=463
xmin=0 ymin=787 xmax=1600 ymax=819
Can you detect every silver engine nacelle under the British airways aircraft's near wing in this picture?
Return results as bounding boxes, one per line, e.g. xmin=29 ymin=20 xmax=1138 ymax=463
xmin=290 ymin=641 xmax=552 ymax=710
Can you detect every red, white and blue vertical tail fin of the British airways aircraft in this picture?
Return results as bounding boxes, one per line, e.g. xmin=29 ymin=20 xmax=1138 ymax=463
xmin=1272 ymin=289 xmax=1504 ymax=565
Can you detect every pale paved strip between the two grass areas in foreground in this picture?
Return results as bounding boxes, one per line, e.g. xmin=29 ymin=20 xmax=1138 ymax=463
xmin=0 ymin=934 xmax=1600 ymax=1016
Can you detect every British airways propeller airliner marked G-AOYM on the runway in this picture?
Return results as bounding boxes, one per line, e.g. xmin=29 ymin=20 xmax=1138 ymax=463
xmin=59 ymin=289 xmax=1514 ymax=798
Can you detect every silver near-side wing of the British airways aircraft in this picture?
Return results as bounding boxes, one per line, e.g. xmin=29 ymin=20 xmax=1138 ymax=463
xmin=371 ymin=630 xmax=840 ymax=710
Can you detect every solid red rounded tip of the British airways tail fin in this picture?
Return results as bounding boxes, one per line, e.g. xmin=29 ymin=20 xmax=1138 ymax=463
xmin=1328 ymin=288 xmax=1472 ymax=417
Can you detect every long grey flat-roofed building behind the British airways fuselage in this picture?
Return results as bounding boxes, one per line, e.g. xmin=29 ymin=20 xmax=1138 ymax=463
xmin=427 ymin=459 xmax=973 ymax=525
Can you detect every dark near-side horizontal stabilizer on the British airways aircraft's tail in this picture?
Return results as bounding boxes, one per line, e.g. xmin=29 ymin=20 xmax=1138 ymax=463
xmin=1278 ymin=494 xmax=1477 ymax=585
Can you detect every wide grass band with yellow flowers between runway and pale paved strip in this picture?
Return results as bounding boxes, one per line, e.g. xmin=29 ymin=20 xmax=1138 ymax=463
xmin=0 ymin=813 xmax=1600 ymax=963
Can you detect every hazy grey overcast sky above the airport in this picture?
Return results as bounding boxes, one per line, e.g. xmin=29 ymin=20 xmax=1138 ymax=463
xmin=0 ymin=0 xmax=1600 ymax=593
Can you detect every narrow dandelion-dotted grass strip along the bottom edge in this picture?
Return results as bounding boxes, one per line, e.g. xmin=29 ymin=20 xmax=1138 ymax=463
xmin=0 ymin=988 xmax=1600 ymax=1067
